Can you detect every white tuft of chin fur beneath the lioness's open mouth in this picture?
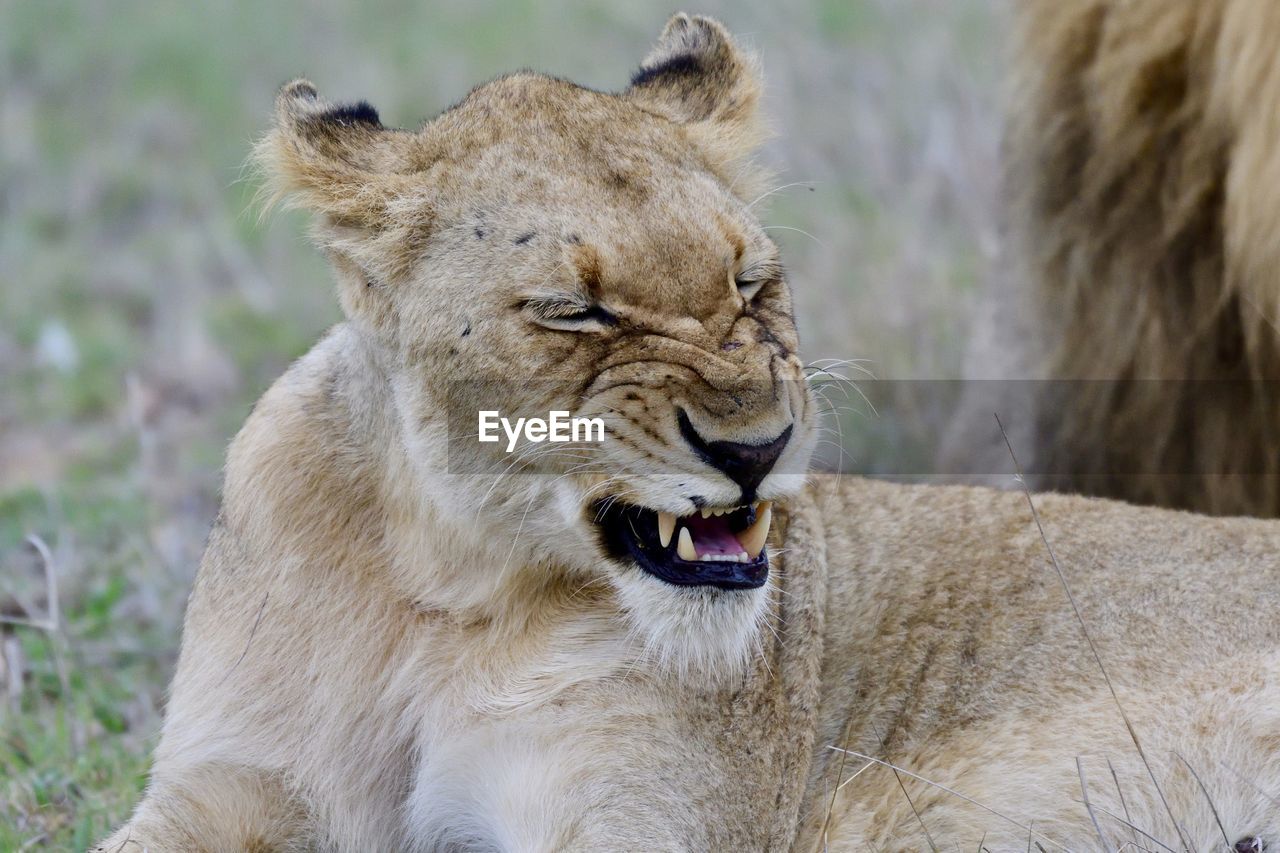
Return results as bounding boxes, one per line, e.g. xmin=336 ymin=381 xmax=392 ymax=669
xmin=613 ymin=566 xmax=773 ymax=679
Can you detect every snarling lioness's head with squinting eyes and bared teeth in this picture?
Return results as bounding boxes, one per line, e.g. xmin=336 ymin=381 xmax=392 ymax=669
xmin=259 ymin=14 xmax=814 ymax=666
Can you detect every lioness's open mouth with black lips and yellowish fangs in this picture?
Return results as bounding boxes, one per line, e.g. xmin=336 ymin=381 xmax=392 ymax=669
xmin=595 ymin=501 xmax=773 ymax=589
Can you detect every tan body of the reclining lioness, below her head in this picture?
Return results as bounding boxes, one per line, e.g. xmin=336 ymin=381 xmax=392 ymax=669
xmin=105 ymin=329 xmax=1280 ymax=852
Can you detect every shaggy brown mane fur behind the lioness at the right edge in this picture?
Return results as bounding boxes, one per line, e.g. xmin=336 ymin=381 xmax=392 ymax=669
xmin=1005 ymin=0 xmax=1280 ymax=516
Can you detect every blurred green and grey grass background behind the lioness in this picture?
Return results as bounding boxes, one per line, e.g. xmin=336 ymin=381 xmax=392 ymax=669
xmin=0 ymin=0 xmax=1005 ymax=850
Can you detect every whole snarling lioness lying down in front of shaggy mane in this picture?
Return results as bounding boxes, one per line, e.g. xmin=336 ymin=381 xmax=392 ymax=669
xmin=96 ymin=14 xmax=1280 ymax=852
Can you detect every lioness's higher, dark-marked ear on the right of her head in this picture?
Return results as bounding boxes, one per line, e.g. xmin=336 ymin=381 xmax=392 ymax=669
xmin=626 ymin=13 xmax=768 ymax=194
